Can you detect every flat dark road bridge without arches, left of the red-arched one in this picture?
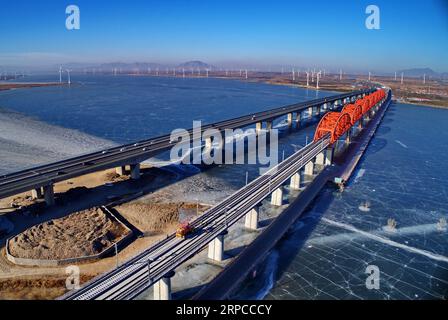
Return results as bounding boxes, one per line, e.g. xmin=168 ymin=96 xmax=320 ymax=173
xmin=0 ymin=88 xmax=375 ymax=205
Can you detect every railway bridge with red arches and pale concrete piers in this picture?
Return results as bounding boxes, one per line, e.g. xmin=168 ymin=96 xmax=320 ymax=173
xmin=61 ymin=90 xmax=390 ymax=300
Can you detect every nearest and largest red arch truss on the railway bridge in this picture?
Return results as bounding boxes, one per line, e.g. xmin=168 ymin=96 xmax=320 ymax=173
xmin=314 ymin=112 xmax=352 ymax=143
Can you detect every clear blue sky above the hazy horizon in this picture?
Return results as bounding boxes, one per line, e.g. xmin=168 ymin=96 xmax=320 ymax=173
xmin=0 ymin=0 xmax=448 ymax=72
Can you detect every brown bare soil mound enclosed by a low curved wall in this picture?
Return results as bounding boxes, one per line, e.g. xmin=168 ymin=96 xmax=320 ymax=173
xmin=9 ymin=208 xmax=129 ymax=260
